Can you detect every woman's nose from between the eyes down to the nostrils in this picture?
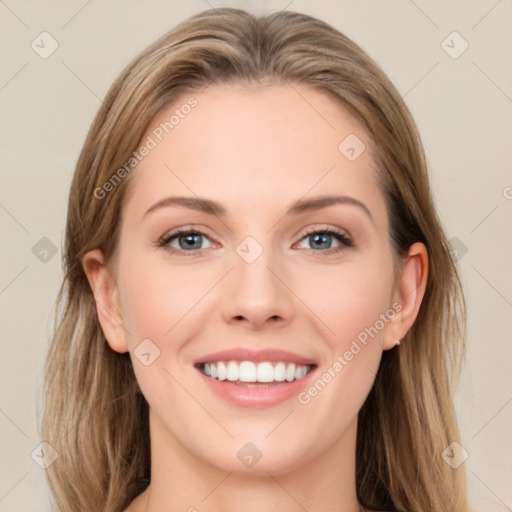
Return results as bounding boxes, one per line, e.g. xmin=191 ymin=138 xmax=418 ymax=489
xmin=223 ymin=236 xmax=293 ymax=328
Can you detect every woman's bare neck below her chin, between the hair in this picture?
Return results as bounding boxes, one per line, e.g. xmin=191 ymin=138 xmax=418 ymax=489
xmin=132 ymin=412 xmax=363 ymax=512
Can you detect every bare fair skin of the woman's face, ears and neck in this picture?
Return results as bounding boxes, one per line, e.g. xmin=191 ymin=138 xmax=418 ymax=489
xmin=83 ymin=84 xmax=428 ymax=512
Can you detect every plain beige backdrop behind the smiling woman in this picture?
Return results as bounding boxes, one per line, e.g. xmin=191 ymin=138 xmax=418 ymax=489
xmin=0 ymin=0 xmax=512 ymax=512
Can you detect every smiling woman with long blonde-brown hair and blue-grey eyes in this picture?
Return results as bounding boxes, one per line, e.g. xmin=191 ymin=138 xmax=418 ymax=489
xmin=42 ymin=8 xmax=468 ymax=512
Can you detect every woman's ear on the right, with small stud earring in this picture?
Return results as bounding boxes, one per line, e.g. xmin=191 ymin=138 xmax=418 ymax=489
xmin=383 ymin=242 xmax=428 ymax=350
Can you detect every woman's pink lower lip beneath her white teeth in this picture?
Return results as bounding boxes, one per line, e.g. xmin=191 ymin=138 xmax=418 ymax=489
xmin=197 ymin=366 xmax=318 ymax=409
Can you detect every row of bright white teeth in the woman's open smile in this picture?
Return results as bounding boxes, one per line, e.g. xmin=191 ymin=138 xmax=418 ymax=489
xmin=202 ymin=361 xmax=311 ymax=382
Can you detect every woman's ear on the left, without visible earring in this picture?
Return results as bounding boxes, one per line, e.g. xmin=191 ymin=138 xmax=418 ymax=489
xmin=82 ymin=249 xmax=128 ymax=353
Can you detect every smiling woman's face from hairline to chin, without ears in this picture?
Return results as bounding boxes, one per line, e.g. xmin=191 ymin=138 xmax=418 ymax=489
xmin=90 ymin=85 xmax=416 ymax=474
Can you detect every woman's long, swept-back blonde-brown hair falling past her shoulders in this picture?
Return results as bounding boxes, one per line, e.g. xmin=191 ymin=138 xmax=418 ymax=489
xmin=42 ymin=8 xmax=469 ymax=512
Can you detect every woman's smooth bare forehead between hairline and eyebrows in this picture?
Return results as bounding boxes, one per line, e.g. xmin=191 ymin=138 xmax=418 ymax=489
xmin=121 ymin=84 xmax=383 ymax=226
